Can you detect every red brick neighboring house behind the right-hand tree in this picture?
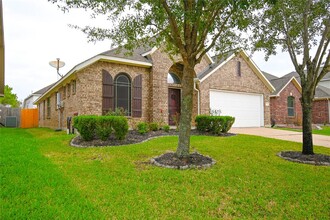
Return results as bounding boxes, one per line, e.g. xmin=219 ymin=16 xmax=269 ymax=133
xmin=264 ymin=72 xmax=330 ymax=125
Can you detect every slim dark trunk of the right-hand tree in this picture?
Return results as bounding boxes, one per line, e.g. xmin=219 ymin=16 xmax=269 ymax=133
xmin=301 ymin=91 xmax=314 ymax=154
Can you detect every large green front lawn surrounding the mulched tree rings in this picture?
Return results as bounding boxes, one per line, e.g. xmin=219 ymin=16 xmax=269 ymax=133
xmin=0 ymin=128 xmax=330 ymax=219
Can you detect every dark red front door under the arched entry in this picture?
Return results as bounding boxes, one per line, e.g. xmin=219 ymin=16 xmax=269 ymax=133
xmin=168 ymin=89 xmax=181 ymax=125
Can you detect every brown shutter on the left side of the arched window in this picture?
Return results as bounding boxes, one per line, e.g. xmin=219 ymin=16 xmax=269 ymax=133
xmin=102 ymin=70 xmax=114 ymax=115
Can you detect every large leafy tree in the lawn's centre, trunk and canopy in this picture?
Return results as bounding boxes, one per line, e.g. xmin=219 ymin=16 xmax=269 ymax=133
xmin=49 ymin=0 xmax=253 ymax=157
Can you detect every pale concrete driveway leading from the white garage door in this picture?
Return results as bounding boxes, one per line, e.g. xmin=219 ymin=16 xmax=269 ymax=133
xmin=229 ymin=128 xmax=330 ymax=148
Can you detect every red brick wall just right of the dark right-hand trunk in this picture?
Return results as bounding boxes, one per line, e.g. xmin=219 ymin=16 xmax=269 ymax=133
xmin=312 ymin=100 xmax=330 ymax=124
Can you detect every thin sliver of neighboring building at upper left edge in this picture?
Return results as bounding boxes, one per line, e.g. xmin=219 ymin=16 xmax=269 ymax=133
xmin=0 ymin=0 xmax=5 ymax=97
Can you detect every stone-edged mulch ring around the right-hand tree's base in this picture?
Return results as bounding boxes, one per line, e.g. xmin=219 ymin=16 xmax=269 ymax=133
xmin=278 ymin=151 xmax=330 ymax=166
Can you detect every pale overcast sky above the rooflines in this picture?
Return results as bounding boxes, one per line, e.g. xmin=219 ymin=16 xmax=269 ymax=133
xmin=2 ymin=0 xmax=294 ymax=101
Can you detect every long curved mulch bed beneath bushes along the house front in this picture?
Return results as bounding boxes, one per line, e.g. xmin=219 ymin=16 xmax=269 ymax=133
xmin=71 ymin=129 xmax=236 ymax=148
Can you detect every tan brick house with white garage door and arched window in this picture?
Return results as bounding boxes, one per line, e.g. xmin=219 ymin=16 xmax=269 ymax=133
xmin=35 ymin=48 xmax=274 ymax=128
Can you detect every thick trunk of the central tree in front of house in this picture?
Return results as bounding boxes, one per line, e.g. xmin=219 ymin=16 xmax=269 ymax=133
xmin=176 ymin=65 xmax=195 ymax=158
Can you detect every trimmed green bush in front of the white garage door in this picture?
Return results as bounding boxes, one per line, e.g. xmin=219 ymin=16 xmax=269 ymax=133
xmin=195 ymin=115 xmax=235 ymax=134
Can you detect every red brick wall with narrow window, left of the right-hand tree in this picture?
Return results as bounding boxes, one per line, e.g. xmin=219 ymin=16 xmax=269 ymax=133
xmin=270 ymin=81 xmax=302 ymax=125
